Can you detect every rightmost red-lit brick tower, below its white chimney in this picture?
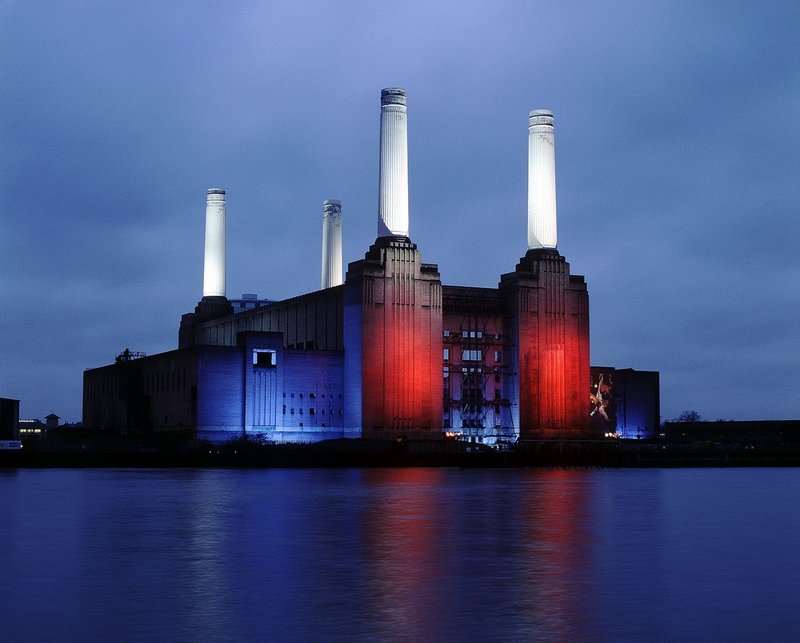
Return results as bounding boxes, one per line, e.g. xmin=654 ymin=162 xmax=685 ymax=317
xmin=500 ymin=249 xmax=589 ymax=438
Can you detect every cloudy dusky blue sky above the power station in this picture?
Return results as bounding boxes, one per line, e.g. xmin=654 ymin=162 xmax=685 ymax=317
xmin=0 ymin=0 xmax=800 ymax=421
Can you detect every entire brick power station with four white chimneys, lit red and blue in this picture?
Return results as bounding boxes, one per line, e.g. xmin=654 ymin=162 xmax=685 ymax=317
xmin=83 ymin=88 xmax=659 ymax=444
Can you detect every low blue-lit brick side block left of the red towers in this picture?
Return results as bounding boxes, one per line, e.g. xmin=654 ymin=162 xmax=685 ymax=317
xmin=83 ymin=332 xmax=352 ymax=442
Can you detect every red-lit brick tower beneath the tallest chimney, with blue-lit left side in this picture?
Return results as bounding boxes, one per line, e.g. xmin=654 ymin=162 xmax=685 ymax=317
xmin=344 ymin=236 xmax=442 ymax=437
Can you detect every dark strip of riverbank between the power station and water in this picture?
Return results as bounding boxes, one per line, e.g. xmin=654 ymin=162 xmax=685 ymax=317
xmin=6 ymin=436 xmax=800 ymax=468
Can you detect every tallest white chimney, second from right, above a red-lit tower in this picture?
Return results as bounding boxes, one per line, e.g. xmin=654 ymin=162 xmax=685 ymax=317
xmin=378 ymin=87 xmax=408 ymax=237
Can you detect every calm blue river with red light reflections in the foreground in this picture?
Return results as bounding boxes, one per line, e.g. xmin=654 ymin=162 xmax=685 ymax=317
xmin=0 ymin=469 xmax=800 ymax=641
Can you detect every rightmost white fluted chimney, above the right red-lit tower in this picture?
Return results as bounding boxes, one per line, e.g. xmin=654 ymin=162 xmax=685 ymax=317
xmin=528 ymin=109 xmax=557 ymax=250
